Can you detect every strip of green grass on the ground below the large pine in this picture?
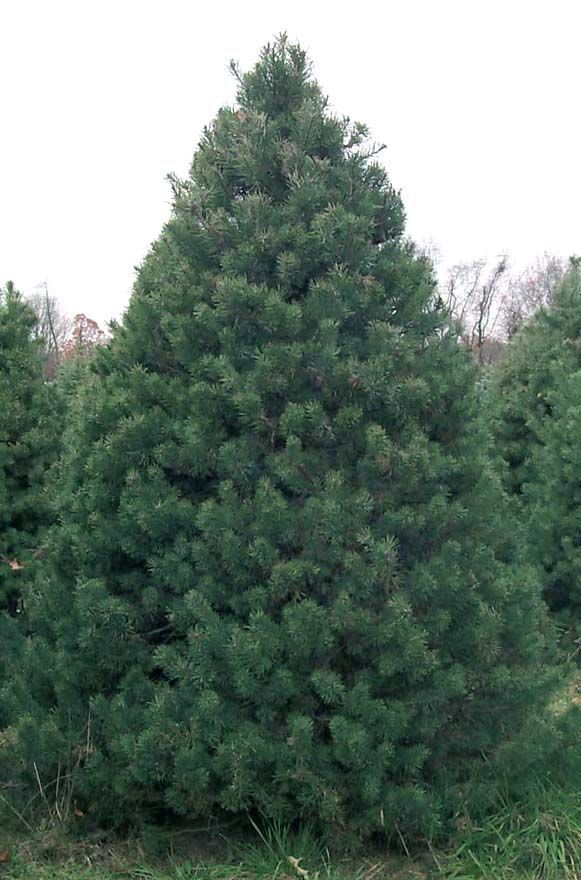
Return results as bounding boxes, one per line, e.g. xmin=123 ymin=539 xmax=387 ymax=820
xmin=0 ymin=785 xmax=581 ymax=880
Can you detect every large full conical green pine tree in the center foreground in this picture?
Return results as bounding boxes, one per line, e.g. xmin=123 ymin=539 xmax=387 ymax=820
xmin=12 ymin=39 xmax=550 ymax=833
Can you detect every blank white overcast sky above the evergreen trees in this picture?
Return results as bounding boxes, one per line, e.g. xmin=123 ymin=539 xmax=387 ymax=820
xmin=0 ymin=0 xmax=581 ymax=321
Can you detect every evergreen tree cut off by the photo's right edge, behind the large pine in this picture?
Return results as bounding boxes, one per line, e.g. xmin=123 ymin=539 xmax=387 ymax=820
xmin=491 ymin=260 xmax=581 ymax=634
